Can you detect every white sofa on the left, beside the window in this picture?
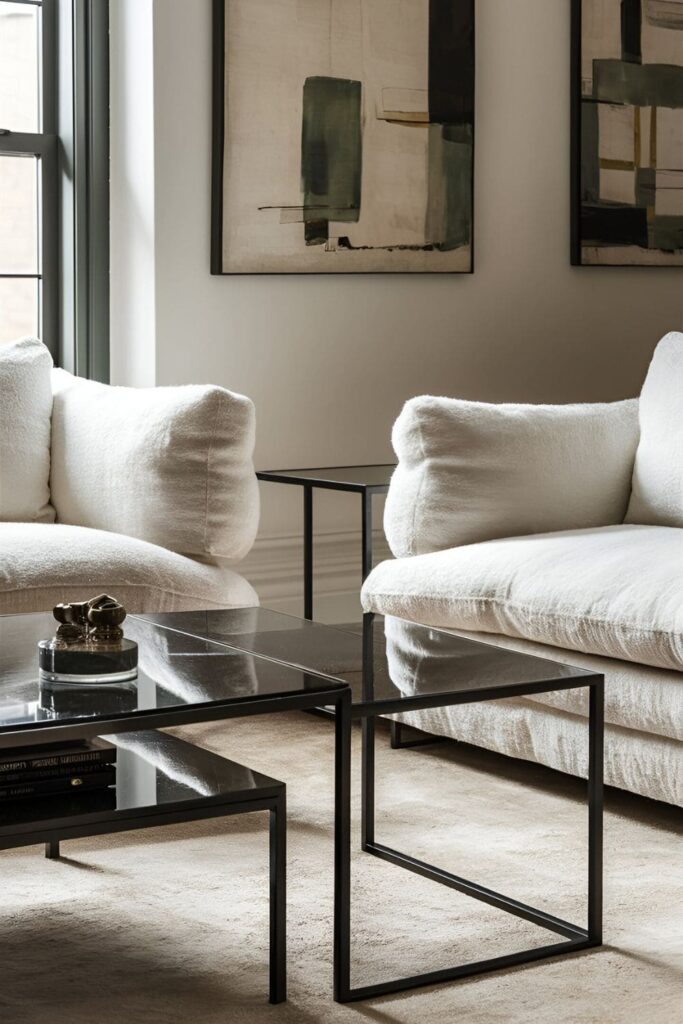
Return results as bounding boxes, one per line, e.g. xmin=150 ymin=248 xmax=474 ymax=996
xmin=0 ymin=338 xmax=259 ymax=613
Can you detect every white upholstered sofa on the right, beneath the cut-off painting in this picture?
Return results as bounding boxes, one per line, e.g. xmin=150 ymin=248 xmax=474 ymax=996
xmin=362 ymin=333 xmax=683 ymax=804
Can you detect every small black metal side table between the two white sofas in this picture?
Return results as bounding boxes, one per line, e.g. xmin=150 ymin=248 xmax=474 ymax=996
xmin=256 ymin=463 xmax=396 ymax=618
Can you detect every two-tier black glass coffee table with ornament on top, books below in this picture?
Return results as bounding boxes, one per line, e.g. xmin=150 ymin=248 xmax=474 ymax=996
xmin=0 ymin=609 xmax=351 ymax=1001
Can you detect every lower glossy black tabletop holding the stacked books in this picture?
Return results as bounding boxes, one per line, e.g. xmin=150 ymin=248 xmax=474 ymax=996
xmin=0 ymin=729 xmax=283 ymax=841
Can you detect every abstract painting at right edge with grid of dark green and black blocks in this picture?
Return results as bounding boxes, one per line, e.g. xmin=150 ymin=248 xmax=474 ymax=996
xmin=571 ymin=0 xmax=683 ymax=266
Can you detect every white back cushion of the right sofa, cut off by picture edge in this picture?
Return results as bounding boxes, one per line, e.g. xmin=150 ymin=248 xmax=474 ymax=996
xmin=626 ymin=331 xmax=683 ymax=526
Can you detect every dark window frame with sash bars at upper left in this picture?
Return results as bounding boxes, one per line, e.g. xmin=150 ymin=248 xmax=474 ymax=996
xmin=0 ymin=0 xmax=110 ymax=381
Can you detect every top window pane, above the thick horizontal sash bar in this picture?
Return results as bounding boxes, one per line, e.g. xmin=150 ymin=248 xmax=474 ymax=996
xmin=0 ymin=0 xmax=40 ymax=131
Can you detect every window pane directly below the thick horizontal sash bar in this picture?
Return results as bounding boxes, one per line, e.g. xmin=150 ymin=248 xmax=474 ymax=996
xmin=0 ymin=156 xmax=38 ymax=273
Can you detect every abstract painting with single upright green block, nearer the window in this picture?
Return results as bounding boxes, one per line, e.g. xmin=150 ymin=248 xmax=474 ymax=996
xmin=211 ymin=0 xmax=474 ymax=273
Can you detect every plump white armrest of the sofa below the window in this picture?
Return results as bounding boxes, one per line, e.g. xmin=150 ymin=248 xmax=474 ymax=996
xmin=50 ymin=370 xmax=259 ymax=561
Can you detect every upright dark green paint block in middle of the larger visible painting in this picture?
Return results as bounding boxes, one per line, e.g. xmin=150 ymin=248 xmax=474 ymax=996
xmin=301 ymin=77 xmax=362 ymax=245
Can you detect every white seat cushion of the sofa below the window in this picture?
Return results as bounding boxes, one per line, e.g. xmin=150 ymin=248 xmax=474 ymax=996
xmin=0 ymin=522 xmax=258 ymax=613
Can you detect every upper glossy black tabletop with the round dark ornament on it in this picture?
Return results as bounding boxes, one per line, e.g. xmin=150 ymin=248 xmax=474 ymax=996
xmin=0 ymin=609 xmax=343 ymax=742
